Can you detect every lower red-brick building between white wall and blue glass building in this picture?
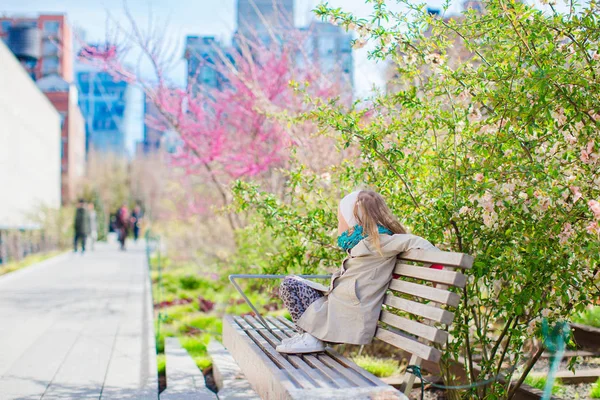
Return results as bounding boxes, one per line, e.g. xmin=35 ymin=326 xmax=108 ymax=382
xmin=37 ymin=75 xmax=85 ymax=204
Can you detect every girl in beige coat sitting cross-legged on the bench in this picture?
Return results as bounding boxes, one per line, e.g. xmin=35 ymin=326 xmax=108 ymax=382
xmin=277 ymin=190 xmax=441 ymax=354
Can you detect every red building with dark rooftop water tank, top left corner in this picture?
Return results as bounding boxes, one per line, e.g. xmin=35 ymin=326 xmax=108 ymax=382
xmin=0 ymin=14 xmax=73 ymax=82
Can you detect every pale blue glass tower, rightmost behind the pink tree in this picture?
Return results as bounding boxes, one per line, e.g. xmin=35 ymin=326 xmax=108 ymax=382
xmin=303 ymin=21 xmax=354 ymax=87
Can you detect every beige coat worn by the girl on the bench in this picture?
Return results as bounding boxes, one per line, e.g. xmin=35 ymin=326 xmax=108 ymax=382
xmin=297 ymin=234 xmax=436 ymax=344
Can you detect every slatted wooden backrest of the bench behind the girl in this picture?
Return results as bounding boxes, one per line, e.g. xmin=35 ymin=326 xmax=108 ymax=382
xmin=375 ymin=250 xmax=473 ymax=393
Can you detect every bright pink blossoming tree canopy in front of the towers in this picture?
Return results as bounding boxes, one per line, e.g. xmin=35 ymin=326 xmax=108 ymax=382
xmin=81 ymin=9 xmax=351 ymax=236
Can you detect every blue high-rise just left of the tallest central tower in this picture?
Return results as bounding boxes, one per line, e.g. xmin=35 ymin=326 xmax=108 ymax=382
xmin=183 ymin=36 xmax=226 ymax=88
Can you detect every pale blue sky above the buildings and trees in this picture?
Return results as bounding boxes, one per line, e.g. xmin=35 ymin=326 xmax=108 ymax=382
xmin=0 ymin=0 xmax=560 ymax=151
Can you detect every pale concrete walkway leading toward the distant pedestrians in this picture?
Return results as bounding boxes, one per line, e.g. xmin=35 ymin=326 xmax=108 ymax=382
xmin=0 ymin=243 xmax=158 ymax=400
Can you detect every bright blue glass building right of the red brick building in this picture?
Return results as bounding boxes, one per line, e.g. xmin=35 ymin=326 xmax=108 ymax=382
xmin=75 ymin=61 xmax=129 ymax=155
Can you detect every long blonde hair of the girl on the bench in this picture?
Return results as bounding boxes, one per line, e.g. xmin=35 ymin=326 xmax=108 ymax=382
xmin=354 ymin=190 xmax=406 ymax=253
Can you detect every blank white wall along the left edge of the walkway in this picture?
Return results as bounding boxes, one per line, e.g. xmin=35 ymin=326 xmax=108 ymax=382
xmin=0 ymin=40 xmax=61 ymax=227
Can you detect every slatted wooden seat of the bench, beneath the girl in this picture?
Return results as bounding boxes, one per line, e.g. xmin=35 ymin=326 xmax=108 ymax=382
xmin=223 ymin=315 xmax=408 ymax=400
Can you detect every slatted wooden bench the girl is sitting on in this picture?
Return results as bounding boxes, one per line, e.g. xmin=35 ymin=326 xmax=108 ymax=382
xmin=223 ymin=250 xmax=473 ymax=400
